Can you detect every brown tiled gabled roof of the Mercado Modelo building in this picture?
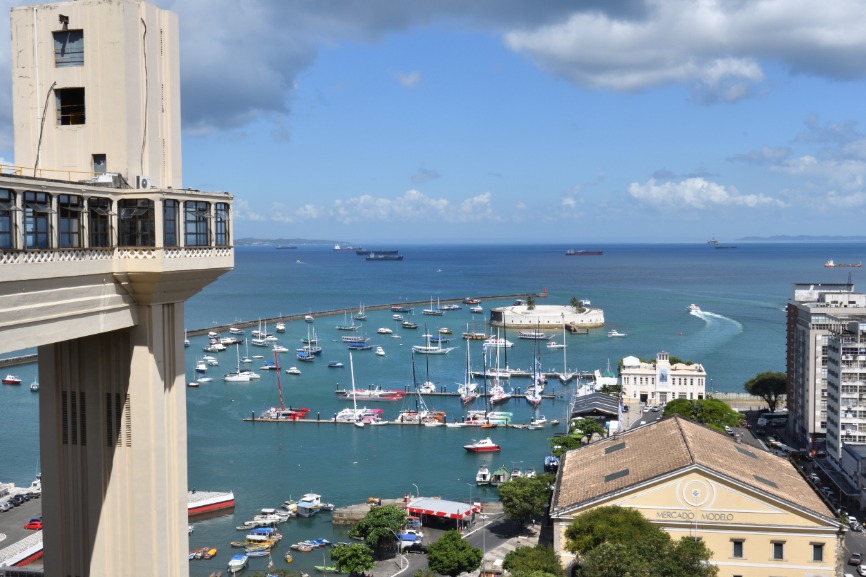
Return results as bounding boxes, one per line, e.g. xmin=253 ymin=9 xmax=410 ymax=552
xmin=553 ymin=416 xmax=834 ymax=518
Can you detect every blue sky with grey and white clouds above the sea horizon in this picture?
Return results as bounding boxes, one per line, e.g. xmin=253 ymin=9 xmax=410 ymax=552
xmin=0 ymin=0 xmax=866 ymax=243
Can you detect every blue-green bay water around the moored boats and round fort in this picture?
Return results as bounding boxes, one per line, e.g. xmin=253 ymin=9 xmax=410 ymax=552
xmin=0 ymin=243 xmax=864 ymax=575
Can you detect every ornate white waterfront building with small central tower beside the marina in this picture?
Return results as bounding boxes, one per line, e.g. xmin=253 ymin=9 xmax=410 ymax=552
xmin=620 ymin=351 xmax=707 ymax=405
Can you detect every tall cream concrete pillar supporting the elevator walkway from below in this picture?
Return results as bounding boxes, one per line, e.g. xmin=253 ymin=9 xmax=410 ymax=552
xmin=39 ymin=303 xmax=189 ymax=577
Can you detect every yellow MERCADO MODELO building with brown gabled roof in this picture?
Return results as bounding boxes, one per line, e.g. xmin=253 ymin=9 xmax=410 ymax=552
xmin=550 ymin=416 xmax=844 ymax=577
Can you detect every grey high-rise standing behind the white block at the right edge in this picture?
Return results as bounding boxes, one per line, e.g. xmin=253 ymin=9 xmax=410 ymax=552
xmin=785 ymin=283 xmax=866 ymax=454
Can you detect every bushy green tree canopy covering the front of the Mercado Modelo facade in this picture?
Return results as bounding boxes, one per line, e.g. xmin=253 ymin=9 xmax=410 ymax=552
xmin=565 ymin=507 xmax=718 ymax=577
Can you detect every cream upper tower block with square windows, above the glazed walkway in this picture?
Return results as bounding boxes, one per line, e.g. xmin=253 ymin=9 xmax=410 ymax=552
xmin=10 ymin=0 xmax=183 ymax=189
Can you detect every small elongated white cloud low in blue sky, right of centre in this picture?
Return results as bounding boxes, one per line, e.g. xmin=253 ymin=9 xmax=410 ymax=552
xmin=628 ymin=178 xmax=785 ymax=209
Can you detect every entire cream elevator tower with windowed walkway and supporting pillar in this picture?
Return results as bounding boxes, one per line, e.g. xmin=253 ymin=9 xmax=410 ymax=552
xmin=0 ymin=0 xmax=234 ymax=577
